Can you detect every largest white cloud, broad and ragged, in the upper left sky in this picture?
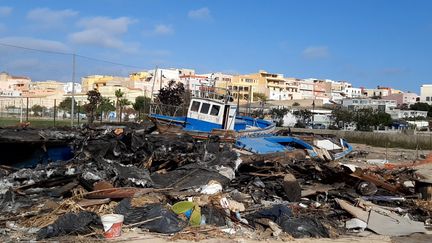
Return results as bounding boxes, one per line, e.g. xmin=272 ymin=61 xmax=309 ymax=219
xmin=69 ymin=17 xmax=136 ymax=51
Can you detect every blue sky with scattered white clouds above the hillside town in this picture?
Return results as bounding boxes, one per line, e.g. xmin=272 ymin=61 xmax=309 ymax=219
xmin=0 ymin=0 xmax=432 ymax=92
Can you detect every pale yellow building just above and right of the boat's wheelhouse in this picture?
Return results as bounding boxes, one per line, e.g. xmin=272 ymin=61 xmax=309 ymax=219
xmin=215 ymin=75 xmax=258 ymax=103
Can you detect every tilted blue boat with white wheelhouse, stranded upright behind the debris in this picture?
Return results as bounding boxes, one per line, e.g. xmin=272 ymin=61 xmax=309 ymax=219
xmin=149 ymin=88 xmax=275 ymax=139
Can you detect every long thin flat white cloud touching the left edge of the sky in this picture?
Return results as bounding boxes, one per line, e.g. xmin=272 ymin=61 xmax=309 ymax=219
xmin=0 ymin=36 xmax=70 ymax=52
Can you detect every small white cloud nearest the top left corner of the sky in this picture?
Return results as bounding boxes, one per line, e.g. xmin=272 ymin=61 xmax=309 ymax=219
xmin=27 ymin=8 xmax=78 ymax=24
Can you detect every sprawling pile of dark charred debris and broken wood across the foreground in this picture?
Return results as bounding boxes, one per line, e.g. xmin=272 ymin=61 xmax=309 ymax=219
xmin=0 ymin=125 xmax=432 ymax=240
